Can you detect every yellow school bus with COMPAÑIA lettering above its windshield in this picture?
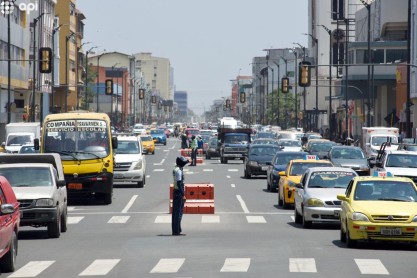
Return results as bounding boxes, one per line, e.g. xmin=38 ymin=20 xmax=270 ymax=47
xmin=35 ymin=111 xmax=117 ymax=204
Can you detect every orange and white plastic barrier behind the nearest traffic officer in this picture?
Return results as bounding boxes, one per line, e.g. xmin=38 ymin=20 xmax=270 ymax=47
xmin=169 ymin=183 xmax=215 ymax=214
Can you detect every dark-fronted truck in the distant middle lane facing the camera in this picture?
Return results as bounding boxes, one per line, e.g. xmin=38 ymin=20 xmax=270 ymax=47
xmin=217 ymin=127 xmax=252 ymax=164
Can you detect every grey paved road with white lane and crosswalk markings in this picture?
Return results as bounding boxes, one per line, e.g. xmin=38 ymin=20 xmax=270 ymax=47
xmin=8 ymin=139 xmax=417 ymax=278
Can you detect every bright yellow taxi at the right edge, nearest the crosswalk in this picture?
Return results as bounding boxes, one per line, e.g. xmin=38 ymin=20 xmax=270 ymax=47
xmin=337 ymin=172 xmax=417 ymax=248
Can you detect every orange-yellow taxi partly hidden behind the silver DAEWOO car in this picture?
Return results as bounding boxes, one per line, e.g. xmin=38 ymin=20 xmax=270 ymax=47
xmin=278 ymin=155 xmax=333 ymax=208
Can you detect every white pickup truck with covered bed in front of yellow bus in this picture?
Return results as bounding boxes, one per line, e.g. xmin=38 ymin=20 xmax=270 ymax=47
xmin=0 ymin=153 xmax=68 ymax=238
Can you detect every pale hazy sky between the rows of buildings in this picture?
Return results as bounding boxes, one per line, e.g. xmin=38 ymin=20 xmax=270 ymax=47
xmin=77 ymin=0 xmax=308 ymax=114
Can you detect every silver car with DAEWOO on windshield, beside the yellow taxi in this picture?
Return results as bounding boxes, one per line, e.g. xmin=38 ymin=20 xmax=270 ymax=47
xmin=294 ymin=167 xmax=358 ymax=228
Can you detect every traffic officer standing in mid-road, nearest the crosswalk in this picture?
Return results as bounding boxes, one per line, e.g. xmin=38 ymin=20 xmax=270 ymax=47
xmin=171 ymin=156 xmax=190 ymax=236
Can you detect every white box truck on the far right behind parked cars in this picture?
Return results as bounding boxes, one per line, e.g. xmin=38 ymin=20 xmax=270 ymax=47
xmin=362 ymin=127 xmax=399 ymax=158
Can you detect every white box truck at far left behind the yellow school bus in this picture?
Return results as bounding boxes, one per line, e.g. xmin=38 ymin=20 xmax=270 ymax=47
xmin=4 ymin=123 xmax=41 ymax=153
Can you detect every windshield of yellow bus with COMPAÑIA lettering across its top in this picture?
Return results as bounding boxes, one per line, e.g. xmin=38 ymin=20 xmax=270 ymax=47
xmin=42 ymin=119 xmax=110 ymax=160
